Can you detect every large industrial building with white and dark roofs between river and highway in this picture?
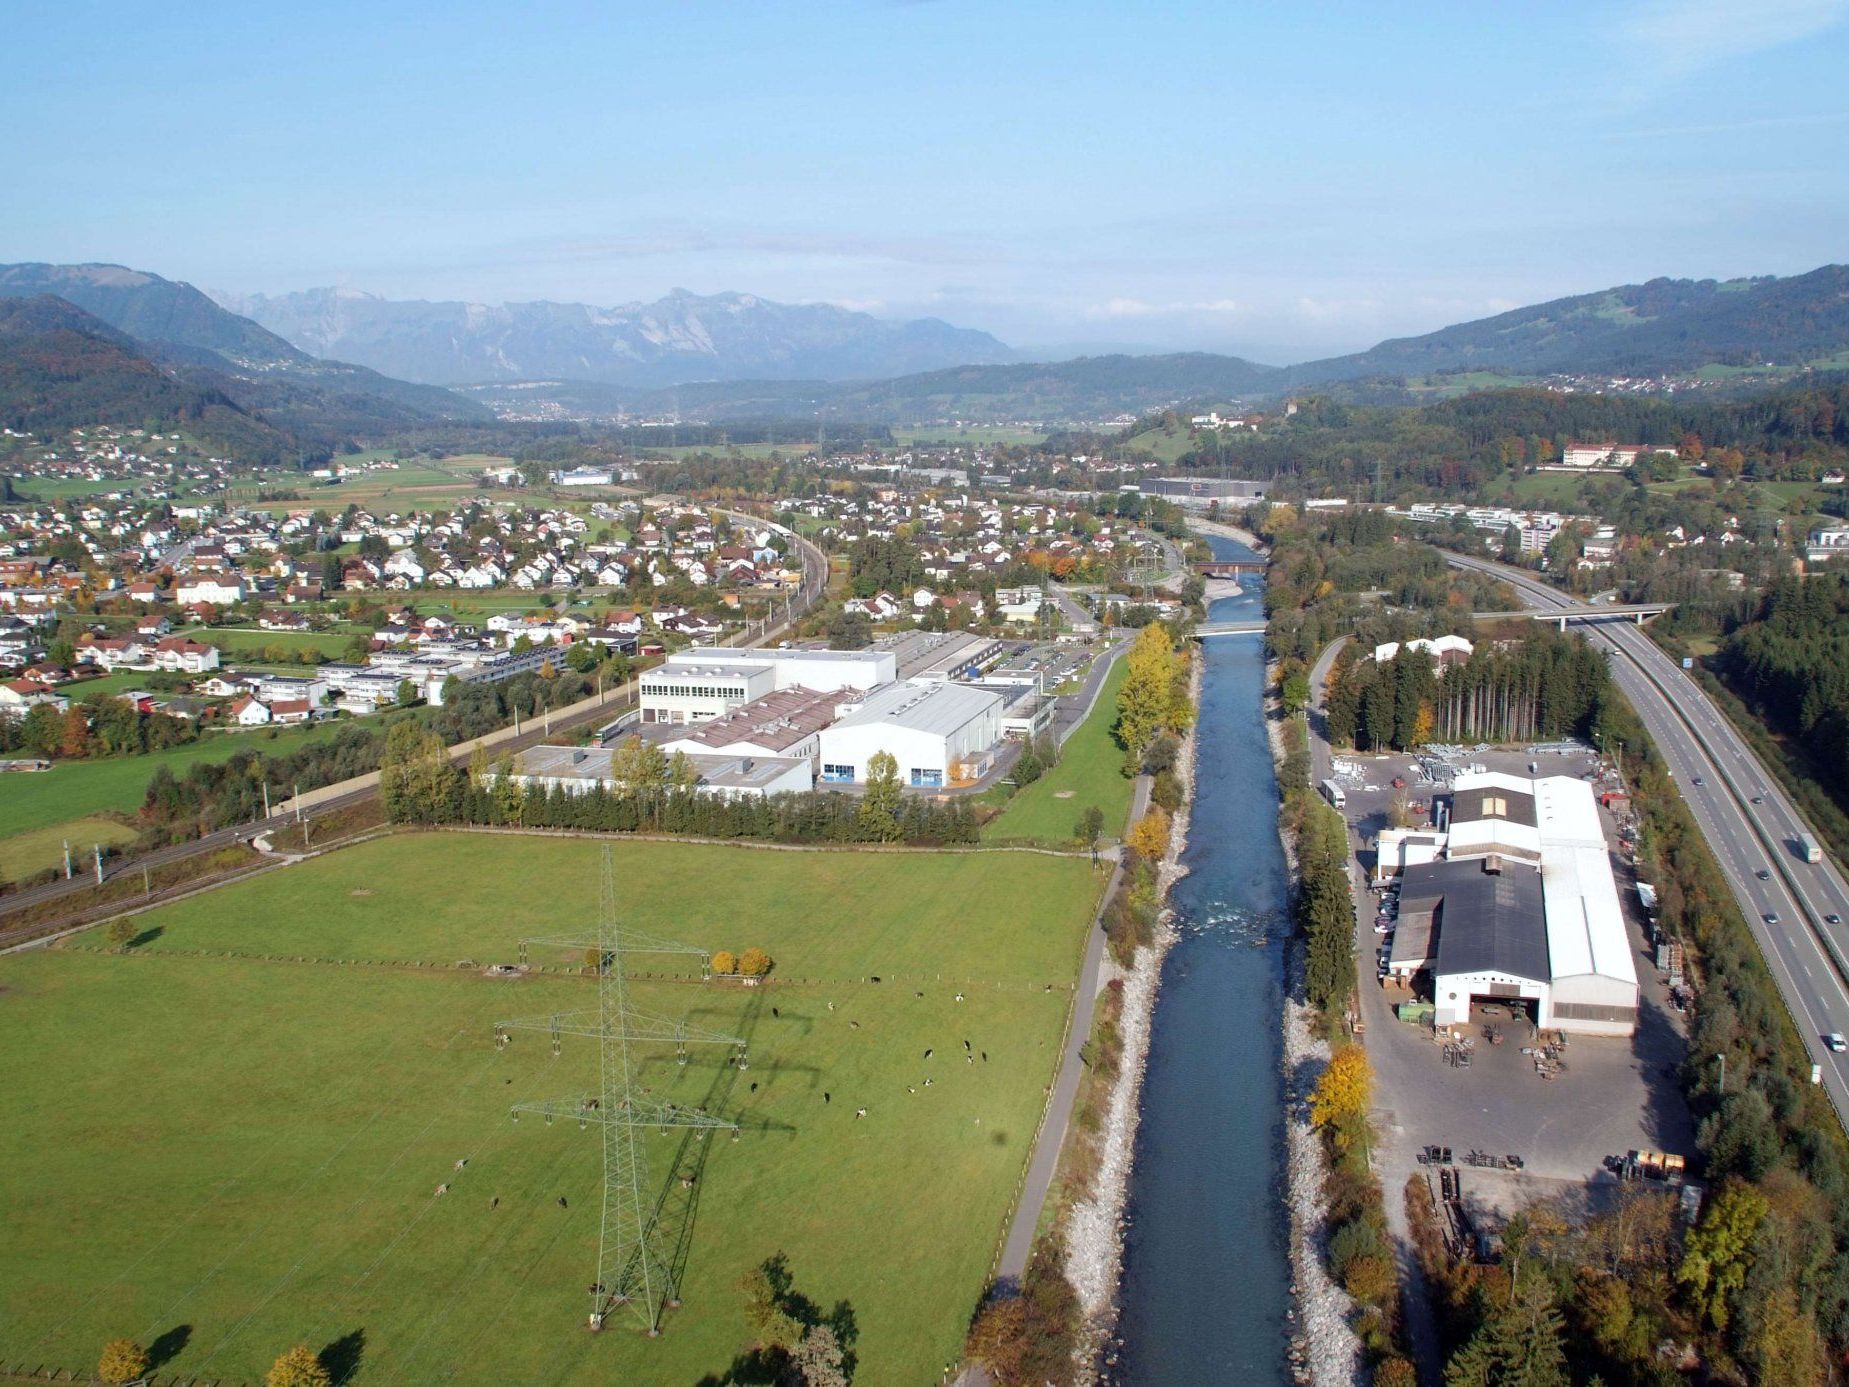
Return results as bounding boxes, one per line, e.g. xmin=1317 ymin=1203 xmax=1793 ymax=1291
xmin=1378 ymin=771 xmax=1638 ymax=1036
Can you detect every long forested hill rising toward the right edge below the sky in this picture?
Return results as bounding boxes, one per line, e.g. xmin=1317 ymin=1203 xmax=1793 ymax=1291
xmin=1285 ymin=264 xmax=1849 ymax=385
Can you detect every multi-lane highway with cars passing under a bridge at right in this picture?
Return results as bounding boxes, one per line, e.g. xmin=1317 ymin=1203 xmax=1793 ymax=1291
xmin=1446 ymin=555 xmax=1849 ymax=1119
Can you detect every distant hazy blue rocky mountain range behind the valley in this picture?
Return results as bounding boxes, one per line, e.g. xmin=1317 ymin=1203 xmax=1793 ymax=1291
xmin=220 ymin=288 xmax=1017 ymax=387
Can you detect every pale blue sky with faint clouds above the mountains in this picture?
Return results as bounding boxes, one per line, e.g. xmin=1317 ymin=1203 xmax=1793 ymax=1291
xmin=0 ymin=0 xmax=1849 ymax=362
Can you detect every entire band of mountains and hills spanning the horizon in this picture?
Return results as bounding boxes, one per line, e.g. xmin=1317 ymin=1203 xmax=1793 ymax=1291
xmin=0 ymin=264 xmax=1849 ymax=453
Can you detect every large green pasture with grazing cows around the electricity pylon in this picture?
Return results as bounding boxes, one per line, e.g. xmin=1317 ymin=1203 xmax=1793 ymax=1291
xmin=0 ymin=834 xmax=1096 ymax=1387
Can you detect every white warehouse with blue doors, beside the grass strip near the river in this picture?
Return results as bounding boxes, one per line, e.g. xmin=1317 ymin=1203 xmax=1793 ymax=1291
xmin=821 ymin=682 xmax=1002 ymax=790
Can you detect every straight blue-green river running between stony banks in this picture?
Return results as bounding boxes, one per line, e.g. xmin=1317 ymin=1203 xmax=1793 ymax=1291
xmin=1111 ymin=538 xmax=1292 ymax=1387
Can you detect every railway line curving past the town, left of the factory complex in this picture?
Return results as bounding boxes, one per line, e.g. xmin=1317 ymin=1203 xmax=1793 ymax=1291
xmin=0 ymin=507 xmax=828 ymax=947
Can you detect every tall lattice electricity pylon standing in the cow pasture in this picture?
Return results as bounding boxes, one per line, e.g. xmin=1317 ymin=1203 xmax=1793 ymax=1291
xmin=494 ymin=847 xmax=745 ymax=1337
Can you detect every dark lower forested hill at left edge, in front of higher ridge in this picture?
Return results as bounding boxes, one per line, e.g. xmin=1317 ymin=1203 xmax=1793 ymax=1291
xmin=0 ymin=294 xmax=300 ymax=464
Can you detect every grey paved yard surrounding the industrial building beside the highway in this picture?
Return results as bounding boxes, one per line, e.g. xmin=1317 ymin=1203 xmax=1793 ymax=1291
xmin=1341 ymin=747 xmax=1694 ymax=1224
